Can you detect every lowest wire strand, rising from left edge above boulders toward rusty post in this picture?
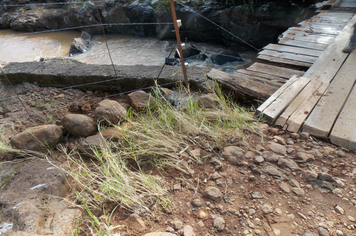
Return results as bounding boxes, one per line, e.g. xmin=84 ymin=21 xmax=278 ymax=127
xmin=0 ymin=81 xmax=179 ymax=121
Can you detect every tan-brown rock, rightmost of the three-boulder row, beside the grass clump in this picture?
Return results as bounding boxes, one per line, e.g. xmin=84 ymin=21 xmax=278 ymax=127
xmin=95 ymin=99 xmax=126 ymax=125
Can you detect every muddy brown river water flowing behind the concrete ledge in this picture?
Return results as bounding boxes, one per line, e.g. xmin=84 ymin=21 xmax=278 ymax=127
xmin=0 ymin=30 xmax=256 ymax=72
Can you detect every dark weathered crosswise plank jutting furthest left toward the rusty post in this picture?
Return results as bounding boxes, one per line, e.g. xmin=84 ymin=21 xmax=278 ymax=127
xmin=208 ymin=69 xmax=280 ymax=100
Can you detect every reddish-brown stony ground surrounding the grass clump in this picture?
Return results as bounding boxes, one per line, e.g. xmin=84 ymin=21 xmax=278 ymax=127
xmin=0 ymin=81 xmax=356 ymax=236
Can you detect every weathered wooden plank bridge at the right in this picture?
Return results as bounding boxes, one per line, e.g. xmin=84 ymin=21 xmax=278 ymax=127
xmin=208 ymin=0 xmax=356 ymax=149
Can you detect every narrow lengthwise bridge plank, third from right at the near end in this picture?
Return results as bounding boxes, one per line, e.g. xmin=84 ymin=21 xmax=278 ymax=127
xmin=286 ymin=80 xmax=329 ymax=132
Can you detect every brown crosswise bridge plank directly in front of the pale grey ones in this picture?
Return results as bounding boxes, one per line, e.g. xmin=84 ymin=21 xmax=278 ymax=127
xmin=247 ymin=62 xmax=304 ymax=79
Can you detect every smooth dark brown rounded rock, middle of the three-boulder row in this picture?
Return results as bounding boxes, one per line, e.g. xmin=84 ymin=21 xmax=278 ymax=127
xmin=62 ymin=114 xmax=98 ymax=137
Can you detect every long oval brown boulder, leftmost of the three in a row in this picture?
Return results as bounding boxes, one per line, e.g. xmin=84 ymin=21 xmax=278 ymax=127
xmin=10 ymin=125 xmax=63 ymax=150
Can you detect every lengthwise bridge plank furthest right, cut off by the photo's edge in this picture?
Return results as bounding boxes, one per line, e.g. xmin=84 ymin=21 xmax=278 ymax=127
xmin=330 ymin=84 xmax=356 ymax=150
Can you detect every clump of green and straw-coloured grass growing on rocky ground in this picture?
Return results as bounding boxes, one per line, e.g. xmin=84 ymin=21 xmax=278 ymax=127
xmin=62 ymin=83 xmax=260 ymax=232
